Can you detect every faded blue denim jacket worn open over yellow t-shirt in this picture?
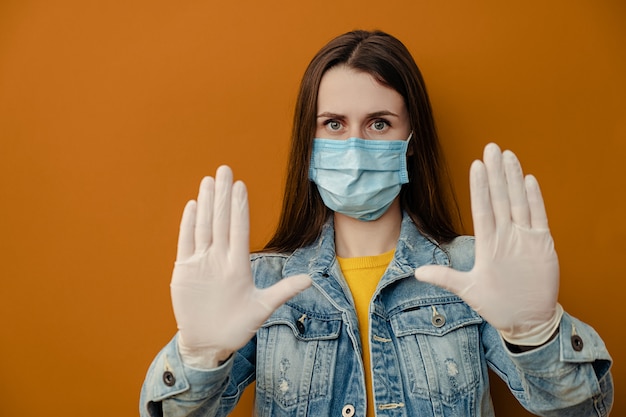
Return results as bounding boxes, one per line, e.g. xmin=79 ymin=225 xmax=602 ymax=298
xmin=140 ymin=214 xmax=613 ymax=417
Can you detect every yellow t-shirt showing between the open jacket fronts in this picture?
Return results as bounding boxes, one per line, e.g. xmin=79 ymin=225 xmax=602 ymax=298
xmin=337 ymin=249 xmax=395 ymax=417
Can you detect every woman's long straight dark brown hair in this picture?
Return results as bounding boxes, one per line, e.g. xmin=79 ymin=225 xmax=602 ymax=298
xmin=264 ymin=30 xmax=460 ymax=252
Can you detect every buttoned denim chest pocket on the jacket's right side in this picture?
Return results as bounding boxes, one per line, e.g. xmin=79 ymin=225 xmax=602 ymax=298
xmin=390 ymin=301 xmax=483 ymax=407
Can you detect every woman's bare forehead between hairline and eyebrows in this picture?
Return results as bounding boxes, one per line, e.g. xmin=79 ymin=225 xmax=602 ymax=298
xmin=317 ymin=66 xmax=404 ymax=115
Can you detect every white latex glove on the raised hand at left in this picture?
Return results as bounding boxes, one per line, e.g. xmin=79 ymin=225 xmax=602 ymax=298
xmin=170 ymin=166 xmax=311 ymax=368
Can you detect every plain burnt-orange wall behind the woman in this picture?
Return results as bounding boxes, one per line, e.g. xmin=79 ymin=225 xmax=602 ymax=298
xmin=0 ymin=0 xmax=626 ymax=417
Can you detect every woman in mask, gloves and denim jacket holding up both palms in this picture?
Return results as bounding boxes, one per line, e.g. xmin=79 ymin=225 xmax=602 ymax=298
xmin=140 ymin=31 xmax=613 ymax=417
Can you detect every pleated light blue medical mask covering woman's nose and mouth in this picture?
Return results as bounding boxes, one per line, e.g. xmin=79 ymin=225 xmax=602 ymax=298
xmin=309 ymin=133 xmax=413 ymax=221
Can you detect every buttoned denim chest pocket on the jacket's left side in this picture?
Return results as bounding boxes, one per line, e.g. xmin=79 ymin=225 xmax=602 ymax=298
xmin=257 ymin=304 xmax=342 ymax=410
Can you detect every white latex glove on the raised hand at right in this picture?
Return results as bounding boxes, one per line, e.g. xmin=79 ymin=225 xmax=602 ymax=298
xmin=415 ymin=143 xmax=563 ymax=346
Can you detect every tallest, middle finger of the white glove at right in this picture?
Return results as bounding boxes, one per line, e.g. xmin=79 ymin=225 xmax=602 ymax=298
xmin=483 ymin=143 xmax=511 ymax=226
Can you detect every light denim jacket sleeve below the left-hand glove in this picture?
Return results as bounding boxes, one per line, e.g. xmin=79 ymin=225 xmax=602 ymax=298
xmin=139 ymin=337 xmax=256 ymax=417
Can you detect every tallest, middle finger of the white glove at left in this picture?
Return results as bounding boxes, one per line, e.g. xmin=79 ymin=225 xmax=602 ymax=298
xmin=213 ymin=165 xmax=233 ymax=247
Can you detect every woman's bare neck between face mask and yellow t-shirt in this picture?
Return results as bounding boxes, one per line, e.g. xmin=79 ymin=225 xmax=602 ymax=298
xmin=334 ymin=198 xmax=402 ymax=258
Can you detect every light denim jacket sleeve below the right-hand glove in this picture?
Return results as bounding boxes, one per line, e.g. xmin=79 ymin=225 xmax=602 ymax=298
xmin=483 ymin=313 xmax=613 ymax=417
